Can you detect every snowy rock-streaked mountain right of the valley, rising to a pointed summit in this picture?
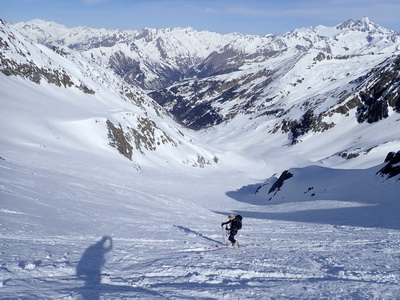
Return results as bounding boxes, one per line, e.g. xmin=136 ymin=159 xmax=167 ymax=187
xmin=146 ymin=18 xmax=400 ymax=178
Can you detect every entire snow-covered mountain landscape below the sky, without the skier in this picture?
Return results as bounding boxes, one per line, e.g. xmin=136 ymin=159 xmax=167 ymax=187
xmin=0 ymin=18 xmax=400 ymax=300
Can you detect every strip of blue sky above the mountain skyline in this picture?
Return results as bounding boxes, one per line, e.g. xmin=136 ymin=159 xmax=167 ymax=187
xmin=0 ymin=0 xmax=400 ymax=35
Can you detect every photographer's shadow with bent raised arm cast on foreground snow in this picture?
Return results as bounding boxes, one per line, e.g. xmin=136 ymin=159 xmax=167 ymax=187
xmin=74 ymin=236 xmax=160 ymax=300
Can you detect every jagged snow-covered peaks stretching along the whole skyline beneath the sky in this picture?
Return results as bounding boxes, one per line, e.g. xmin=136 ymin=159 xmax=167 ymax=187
xmin=16 ymin=18 xmax=400 ymax=90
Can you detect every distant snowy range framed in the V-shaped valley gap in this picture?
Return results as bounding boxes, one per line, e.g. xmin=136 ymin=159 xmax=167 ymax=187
xmin=16 ymin=20 xmax=239 ymax=89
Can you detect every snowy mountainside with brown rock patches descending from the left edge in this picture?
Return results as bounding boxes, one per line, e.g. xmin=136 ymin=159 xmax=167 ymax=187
xmin=0 ymin=18 xmax=217 ymax=167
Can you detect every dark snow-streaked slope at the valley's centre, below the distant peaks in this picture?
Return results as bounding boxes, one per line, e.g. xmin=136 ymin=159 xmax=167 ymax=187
xmin=149 ymin=69 xmax=274 ymax=130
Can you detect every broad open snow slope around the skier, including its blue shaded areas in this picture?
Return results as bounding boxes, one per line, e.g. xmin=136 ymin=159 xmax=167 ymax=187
xmin=0 ymin=75 xmax=400 ymax=299
